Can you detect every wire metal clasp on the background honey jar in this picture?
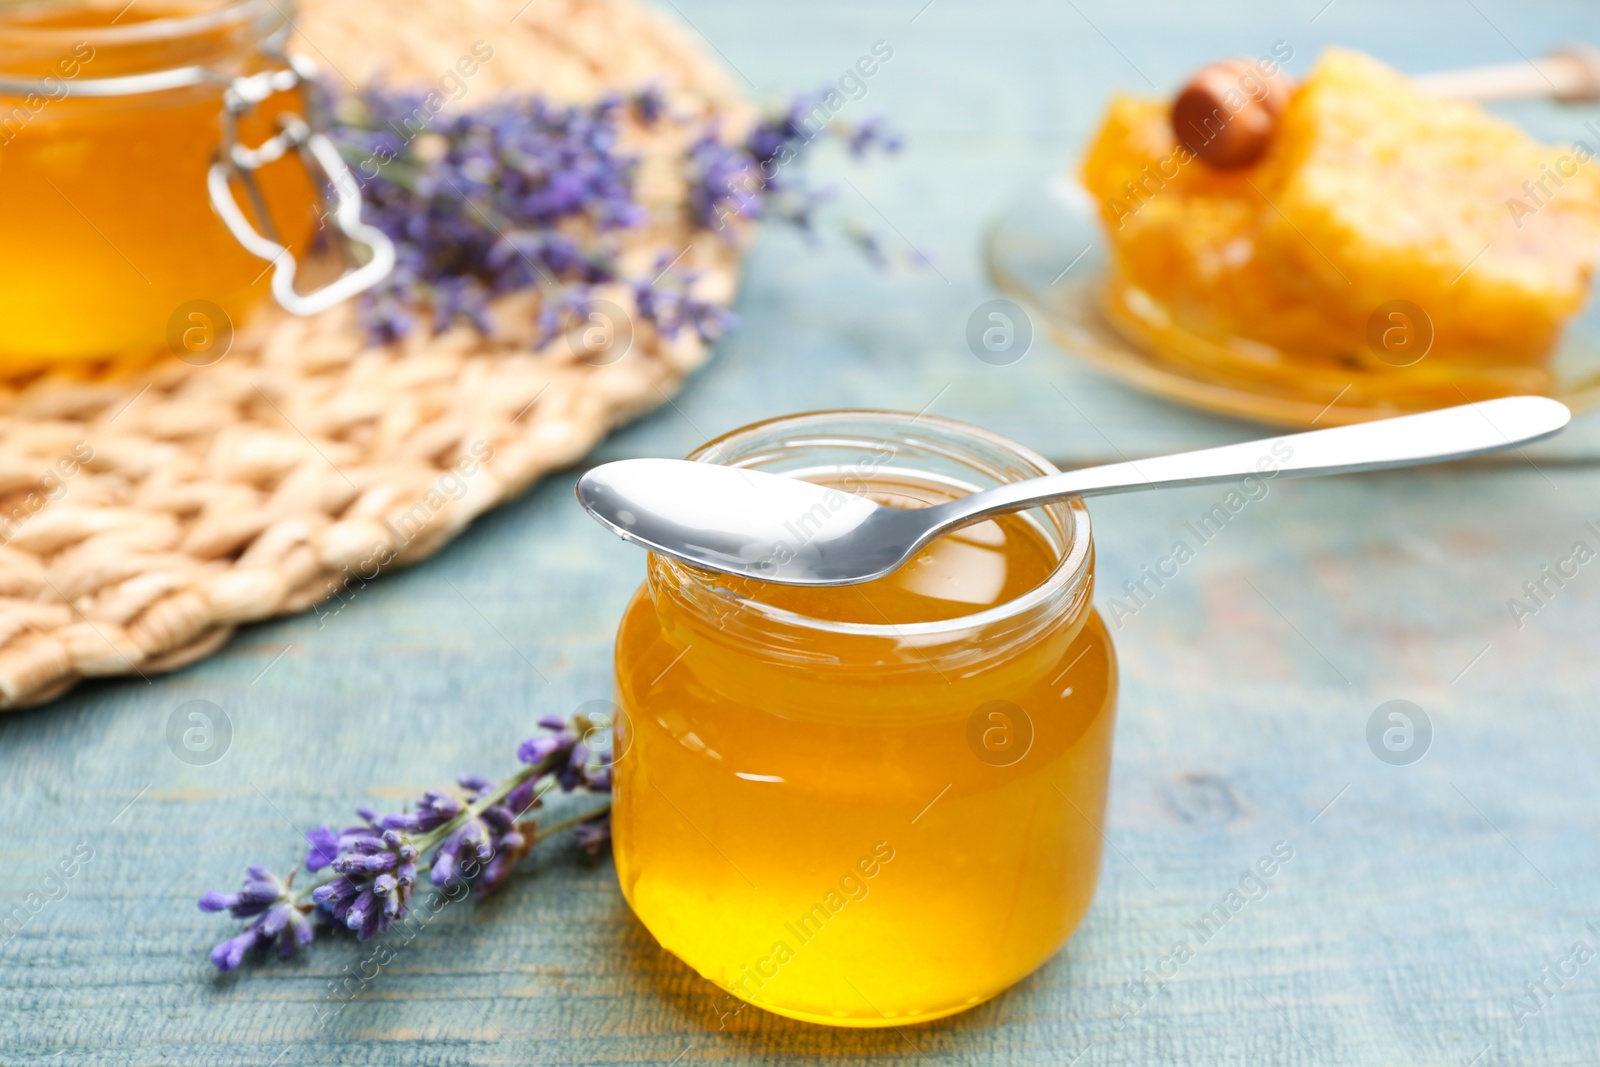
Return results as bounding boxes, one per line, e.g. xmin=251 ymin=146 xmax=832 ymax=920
xmin=206 ymin=54 xmax=395 ymax=315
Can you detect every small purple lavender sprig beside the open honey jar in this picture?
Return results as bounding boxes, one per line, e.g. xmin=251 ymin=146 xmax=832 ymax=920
xmin=200 ymin=715 xmax=611 ymax=971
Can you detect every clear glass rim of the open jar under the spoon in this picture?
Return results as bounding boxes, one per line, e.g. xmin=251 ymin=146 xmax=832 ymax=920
xmin=650 ymin=408 xmax=1093 ymax=640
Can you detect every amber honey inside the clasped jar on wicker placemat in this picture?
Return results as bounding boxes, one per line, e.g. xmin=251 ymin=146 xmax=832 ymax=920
xmin=0 ymin=0 xmax=315 ymax=369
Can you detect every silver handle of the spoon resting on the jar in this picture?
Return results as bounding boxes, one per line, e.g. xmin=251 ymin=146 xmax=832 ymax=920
xmin=939 ymin=397 xmax=1573 ymax=523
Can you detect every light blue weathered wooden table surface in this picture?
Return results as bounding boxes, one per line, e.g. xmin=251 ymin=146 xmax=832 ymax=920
xmin=0 ymin=0 xmax=1600 ymax=1067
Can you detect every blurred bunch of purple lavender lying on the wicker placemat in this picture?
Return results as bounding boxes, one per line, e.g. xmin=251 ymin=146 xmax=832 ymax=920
xmin=324 ymin=88 xmax=899 ymax=347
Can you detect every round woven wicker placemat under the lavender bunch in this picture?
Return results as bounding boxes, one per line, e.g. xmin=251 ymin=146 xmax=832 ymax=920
xmin=0 ymin=0 xmax=744 ymax=709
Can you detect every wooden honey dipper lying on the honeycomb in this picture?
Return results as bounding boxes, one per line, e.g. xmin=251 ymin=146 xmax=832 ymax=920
xmin=1173 ymin=45 xmax=1600 ymax=168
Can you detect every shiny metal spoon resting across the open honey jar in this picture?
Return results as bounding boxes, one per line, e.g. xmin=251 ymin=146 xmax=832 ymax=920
xmin=578 ymin=397 xmax=1571 ymax=585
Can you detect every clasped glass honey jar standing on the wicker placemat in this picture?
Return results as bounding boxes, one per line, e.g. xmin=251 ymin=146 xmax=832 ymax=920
xmin=0 ymin=0 xmax=392 ymax=374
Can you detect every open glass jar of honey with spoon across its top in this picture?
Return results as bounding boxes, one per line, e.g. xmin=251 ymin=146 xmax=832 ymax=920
xmin=614 ymin=411 xmax=1117 ymax=1027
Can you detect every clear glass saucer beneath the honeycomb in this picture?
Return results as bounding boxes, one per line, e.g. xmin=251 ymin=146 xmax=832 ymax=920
xmin=984 ymin=176 xmax=1600 ymax=427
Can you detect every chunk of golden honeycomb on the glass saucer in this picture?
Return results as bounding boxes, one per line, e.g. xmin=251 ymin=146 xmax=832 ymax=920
xmin=1082 ymin=50 xmax=1600 ymax=365
